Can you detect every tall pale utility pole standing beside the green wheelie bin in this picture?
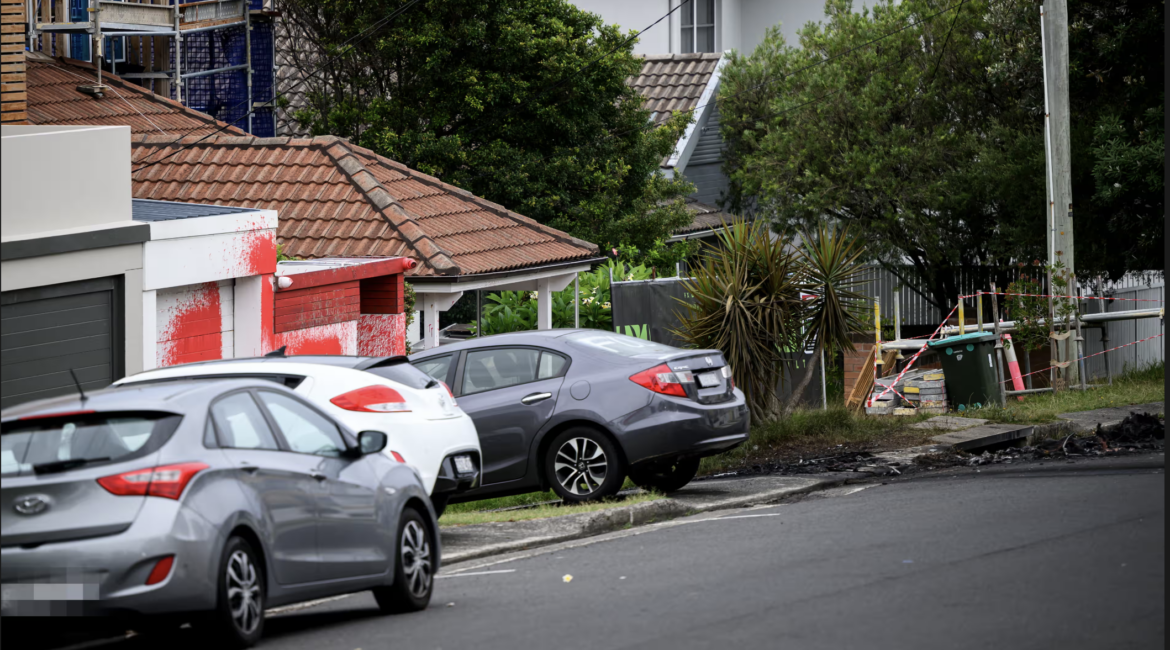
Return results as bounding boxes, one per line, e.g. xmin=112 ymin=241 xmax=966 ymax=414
xmin=1040 ymin=0 xmax=1080 ymax=385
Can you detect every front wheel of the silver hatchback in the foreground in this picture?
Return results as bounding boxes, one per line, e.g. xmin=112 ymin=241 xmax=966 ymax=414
xmin=373 ymin=507 xmax=435 ymax=614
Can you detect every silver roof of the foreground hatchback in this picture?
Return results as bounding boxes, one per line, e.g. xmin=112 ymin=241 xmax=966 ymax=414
xmin=0 ymin=379 xmax=291 ymax=421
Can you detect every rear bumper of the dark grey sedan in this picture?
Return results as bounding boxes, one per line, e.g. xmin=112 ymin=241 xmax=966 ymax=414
xmin=611 ymin=389 xmax=751 ymax=464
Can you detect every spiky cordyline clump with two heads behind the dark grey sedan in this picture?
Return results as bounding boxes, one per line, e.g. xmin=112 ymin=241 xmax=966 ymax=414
xmin=675 ymin=221 xmax=865 ymax=420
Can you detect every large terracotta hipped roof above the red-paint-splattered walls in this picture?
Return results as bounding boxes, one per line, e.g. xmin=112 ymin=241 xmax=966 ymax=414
xmin=132 ymin=136 xmax=598 ymax=276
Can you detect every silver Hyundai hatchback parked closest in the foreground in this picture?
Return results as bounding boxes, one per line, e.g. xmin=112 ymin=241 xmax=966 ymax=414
xmin=0 ymin=380 xmax=439 ymax=648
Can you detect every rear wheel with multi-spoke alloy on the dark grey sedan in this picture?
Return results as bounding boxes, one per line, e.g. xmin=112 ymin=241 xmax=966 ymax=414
xmin=544 ymin=427 xmax=626 ymax=503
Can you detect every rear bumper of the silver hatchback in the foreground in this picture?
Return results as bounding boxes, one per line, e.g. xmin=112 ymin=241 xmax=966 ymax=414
xmin=0 ymin=499 xmax=222 ymax=618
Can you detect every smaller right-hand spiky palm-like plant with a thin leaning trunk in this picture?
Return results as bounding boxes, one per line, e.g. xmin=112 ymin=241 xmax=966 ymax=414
xmin=784 ymin=226 xmax=866 ymax=413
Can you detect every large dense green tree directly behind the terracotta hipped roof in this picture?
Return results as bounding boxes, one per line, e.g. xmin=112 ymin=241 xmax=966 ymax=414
xmin=281 ymin=0 xmax=691 ymax=248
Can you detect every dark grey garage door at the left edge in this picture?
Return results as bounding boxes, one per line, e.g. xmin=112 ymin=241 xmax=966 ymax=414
xmin=0 ymin=276 xmax=123 ymax=408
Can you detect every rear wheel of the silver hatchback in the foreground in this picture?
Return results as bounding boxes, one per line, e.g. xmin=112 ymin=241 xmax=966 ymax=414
xmin=207 ymin=537 xmax=267 ymax=650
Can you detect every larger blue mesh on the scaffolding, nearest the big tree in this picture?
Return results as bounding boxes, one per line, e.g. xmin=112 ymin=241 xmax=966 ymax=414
xmin=183 ymin=26 xmax=249 ymax=130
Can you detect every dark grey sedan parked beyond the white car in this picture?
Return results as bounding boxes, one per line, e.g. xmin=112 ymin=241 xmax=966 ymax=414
xmin=411 ymin=330 xmax=750 ymax=502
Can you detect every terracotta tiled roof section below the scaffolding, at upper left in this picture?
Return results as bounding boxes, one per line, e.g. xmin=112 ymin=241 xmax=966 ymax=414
xmin=26 ymin=53 xmax=245 ymax=138
